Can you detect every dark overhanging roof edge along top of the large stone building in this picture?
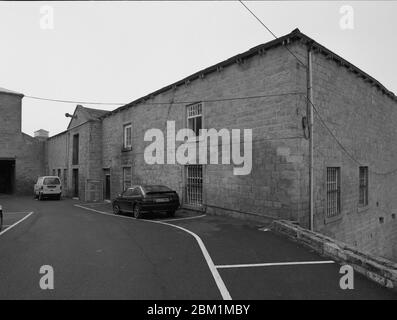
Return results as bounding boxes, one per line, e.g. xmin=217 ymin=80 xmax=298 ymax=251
xmin=101 ymin=28 xmax=397 ymax=118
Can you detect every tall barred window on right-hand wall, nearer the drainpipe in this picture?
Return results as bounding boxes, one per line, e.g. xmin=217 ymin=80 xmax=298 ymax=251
xmin=327 ymin=167 xmax=340 ymax=217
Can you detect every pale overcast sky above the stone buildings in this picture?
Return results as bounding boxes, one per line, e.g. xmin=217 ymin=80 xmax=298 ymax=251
xmin=0 ymin=1 xmax=397 ymax=135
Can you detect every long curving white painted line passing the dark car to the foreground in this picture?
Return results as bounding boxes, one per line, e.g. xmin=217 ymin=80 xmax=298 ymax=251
xmin=74 ymin=204 xmax=232 ymax=300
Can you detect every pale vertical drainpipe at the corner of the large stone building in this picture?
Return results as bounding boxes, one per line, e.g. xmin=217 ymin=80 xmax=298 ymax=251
xmin=307 ymin=43 xmax=314 ymax=231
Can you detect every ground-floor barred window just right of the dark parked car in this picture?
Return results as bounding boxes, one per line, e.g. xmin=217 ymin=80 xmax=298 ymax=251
xmin=185 ymin=165 xmax=203 ymax=207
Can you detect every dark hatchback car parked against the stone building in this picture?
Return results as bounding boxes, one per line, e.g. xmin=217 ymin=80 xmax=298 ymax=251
xmin=113 ymin=185 xmax=179 ymax=219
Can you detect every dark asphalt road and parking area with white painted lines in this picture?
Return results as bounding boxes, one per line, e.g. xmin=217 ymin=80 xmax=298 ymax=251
xmin=0 ymin=197 xmax=397 ymax=299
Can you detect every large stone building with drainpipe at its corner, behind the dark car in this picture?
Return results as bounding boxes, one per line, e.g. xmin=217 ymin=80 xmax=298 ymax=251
xmin=0 ymin=29 xmax=397 ymax=259
